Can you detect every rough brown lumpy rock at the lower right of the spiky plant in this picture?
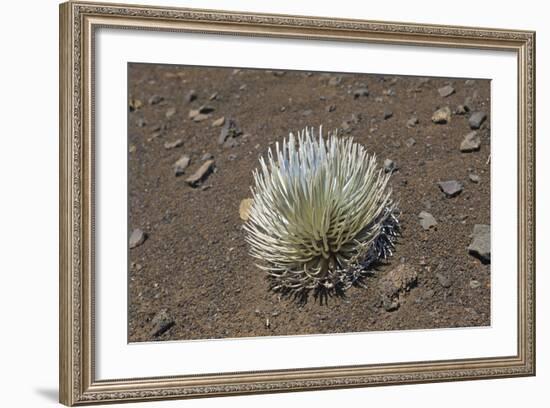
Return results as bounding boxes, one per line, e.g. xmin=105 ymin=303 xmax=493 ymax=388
xmin=379 ymin=263 xmax=417 ymax=312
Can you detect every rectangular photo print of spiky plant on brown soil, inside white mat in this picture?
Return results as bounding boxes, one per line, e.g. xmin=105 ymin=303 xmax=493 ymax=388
xmin=128 ymin=63 xmax=491 ymax=342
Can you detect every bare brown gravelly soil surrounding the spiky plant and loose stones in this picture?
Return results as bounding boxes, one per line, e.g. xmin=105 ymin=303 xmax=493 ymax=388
xmin=128 ymin=64 xmax=491 ymax=342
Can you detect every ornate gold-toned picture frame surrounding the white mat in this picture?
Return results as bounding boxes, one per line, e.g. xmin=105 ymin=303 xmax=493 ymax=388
xmin=59 ymin=2 xmax=535 ymax=405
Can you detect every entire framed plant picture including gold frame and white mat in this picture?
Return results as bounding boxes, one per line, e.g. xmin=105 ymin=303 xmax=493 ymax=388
xmin=60 ymin=2 xmax=535 ymax=405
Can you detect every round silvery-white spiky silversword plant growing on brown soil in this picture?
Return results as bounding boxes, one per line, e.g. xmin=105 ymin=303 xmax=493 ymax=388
xmin=244 ymin=128 xmax=398 ymax=301
